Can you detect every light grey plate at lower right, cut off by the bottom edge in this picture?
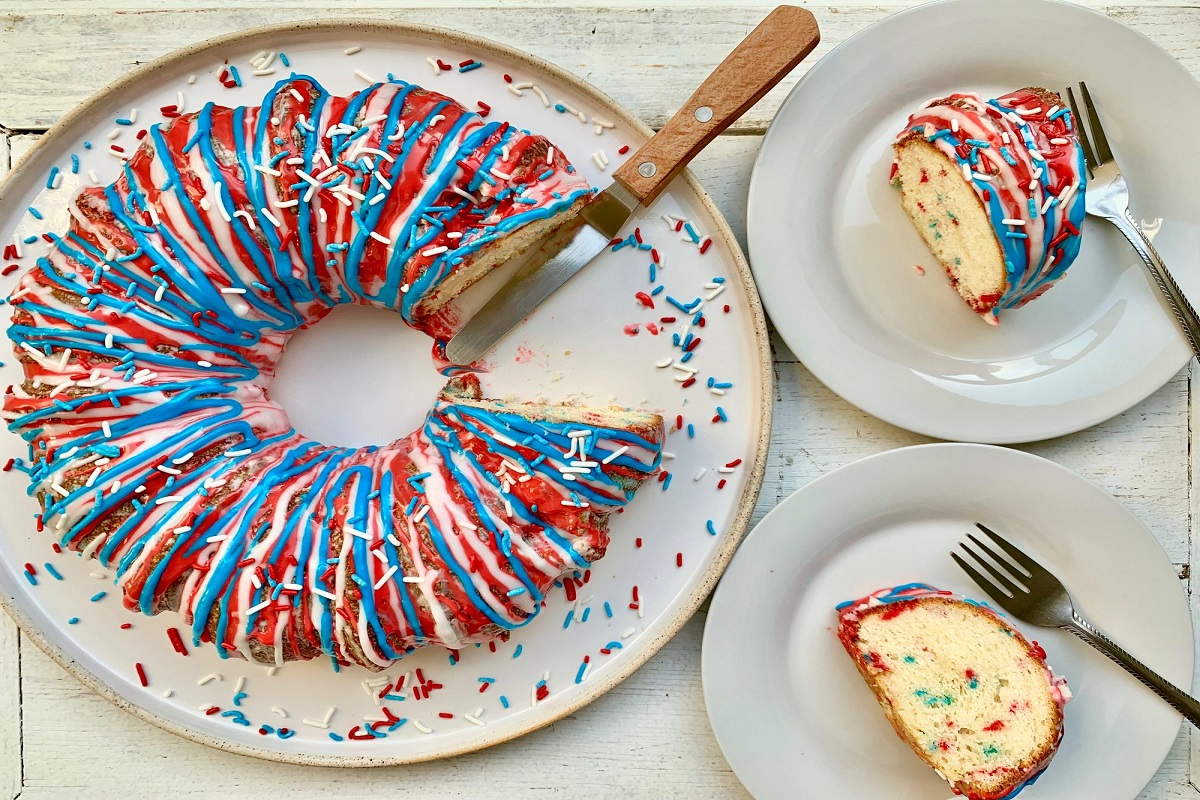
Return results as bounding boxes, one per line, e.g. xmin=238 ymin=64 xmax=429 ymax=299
xmin=701 ymin=444 xmax=1193 ymax=800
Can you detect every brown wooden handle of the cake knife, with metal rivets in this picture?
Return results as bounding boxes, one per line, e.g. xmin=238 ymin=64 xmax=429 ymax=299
xmin=613 ymin=6 xmax=821 ymax=205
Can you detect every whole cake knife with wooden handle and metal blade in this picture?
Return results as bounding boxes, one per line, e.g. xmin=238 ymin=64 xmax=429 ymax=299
xmin=446 ymin=6 xmax=821 ymax=365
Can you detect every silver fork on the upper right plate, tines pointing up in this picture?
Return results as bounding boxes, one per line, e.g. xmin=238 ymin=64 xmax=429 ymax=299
xmin=1067 ymin=82 xmax=1200 ymax=357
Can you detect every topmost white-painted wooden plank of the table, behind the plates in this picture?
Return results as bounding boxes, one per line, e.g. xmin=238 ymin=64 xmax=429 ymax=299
xmin=0 ymin=4 xmax=1200 ymax=131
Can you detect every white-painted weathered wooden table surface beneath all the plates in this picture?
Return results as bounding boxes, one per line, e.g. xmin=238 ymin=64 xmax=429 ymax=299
xmin=0 ymin=0 xmax=1200 ymax=800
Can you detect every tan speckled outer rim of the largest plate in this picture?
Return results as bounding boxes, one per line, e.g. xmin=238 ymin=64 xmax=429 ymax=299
xmin=0 ymin=18 xmax=774 ymax=766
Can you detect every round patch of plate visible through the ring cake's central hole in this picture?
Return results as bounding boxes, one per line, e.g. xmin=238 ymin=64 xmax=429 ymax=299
xmin=270 ymin=306 xmax=446 ymax=447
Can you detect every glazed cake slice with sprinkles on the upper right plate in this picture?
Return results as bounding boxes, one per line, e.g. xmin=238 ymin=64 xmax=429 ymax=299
xmin=892 ymin=89 xmax=1087 ymax=321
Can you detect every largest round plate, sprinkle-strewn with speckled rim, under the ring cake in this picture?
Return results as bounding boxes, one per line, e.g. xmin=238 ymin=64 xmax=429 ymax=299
xmin=0 ymin=23 xmax=770 ymax=765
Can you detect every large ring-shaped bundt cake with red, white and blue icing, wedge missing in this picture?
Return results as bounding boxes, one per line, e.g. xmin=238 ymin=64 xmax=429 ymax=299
xmin=4 ymin=76 xmax=665 ymax=668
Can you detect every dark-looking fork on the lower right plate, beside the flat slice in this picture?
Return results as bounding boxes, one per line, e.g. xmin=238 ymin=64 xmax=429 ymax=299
xmin=950 ymin=522 xmax=1200 ymax=727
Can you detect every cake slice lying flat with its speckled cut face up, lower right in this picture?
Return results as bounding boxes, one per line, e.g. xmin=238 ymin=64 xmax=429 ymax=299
xmin=838 ymin=583 xmax=1070 ymax=800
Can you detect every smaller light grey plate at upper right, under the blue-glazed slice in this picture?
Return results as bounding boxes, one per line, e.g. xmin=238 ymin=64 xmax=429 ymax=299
xmin=749 ymin=0 xmax=1200 ymax=444
